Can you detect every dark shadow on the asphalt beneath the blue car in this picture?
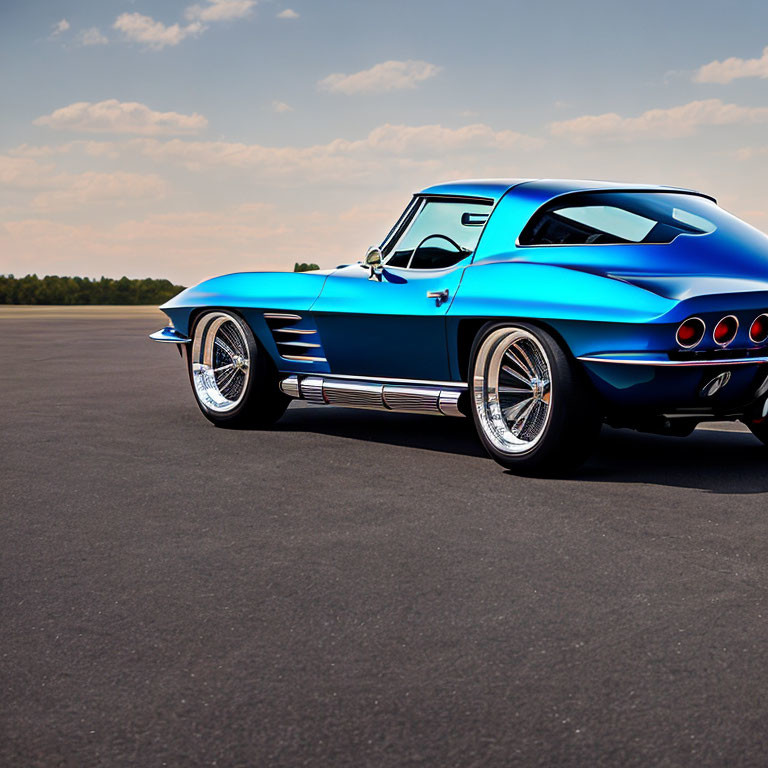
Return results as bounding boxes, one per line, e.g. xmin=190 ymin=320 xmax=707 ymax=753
xmin=279 ymin=403 xmax=768 ymax=494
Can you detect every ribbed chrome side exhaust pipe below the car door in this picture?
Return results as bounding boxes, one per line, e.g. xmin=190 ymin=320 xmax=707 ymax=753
xmin=280 ymin=374 xmax=466 ymax=416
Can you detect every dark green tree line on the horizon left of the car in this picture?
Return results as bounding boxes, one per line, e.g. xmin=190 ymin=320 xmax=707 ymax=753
xmin=0 ymin=275 xmax=184 ymax=305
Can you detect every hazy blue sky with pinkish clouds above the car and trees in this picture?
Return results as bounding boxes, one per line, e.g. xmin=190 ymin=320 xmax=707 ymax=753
xmin=0 ymin=0 xmax=768 ymax=285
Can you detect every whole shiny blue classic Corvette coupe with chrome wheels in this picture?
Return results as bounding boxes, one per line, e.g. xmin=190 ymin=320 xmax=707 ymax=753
xmin=152 ymin=179 xmax=768 ymax=474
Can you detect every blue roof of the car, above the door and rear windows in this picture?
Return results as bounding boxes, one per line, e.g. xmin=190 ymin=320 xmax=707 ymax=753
xmin=418 ymin=179 xmax=715 ymax=202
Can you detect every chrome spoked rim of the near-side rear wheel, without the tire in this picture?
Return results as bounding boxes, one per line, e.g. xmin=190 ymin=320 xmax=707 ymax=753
xmin=473 ymin=327 xmax=553 ymax=455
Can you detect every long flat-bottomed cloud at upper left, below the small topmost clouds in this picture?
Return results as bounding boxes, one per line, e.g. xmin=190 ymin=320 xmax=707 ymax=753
xmin=33 ymin=99 xmax=208 ymax=136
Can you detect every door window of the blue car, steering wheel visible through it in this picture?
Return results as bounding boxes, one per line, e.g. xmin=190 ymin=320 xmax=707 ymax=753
xmin=384 ymin=199 xmax=491 ymax=269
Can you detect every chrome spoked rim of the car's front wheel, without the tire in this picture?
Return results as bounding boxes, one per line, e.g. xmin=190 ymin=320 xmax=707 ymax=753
xmin=191 ymin=312 xmax=251 ymax=413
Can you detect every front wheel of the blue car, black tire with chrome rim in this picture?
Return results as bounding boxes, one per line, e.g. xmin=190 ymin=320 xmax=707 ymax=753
xmin=187 ymin=310 xmax=291 ymax=429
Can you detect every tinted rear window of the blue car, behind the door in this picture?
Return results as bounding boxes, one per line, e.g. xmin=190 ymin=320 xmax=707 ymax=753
xmin=519 ymin=192 xmax=717 ymax=245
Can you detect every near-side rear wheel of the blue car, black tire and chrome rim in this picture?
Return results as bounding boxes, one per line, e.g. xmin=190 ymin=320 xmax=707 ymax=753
xmin=469 ymin=322 xmax=602 ymax=475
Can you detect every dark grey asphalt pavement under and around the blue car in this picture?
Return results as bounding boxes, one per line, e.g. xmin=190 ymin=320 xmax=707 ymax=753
xmin=0 ymin=312 xmax=768 ymax=768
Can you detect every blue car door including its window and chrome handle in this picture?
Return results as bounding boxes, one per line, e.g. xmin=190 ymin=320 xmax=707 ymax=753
xmin=312 ymin=197 xmax=490 ymax=381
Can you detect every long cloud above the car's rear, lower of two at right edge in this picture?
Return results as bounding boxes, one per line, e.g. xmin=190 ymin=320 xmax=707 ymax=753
xmin=549 ymin=99 xmax=768 ymax=143
